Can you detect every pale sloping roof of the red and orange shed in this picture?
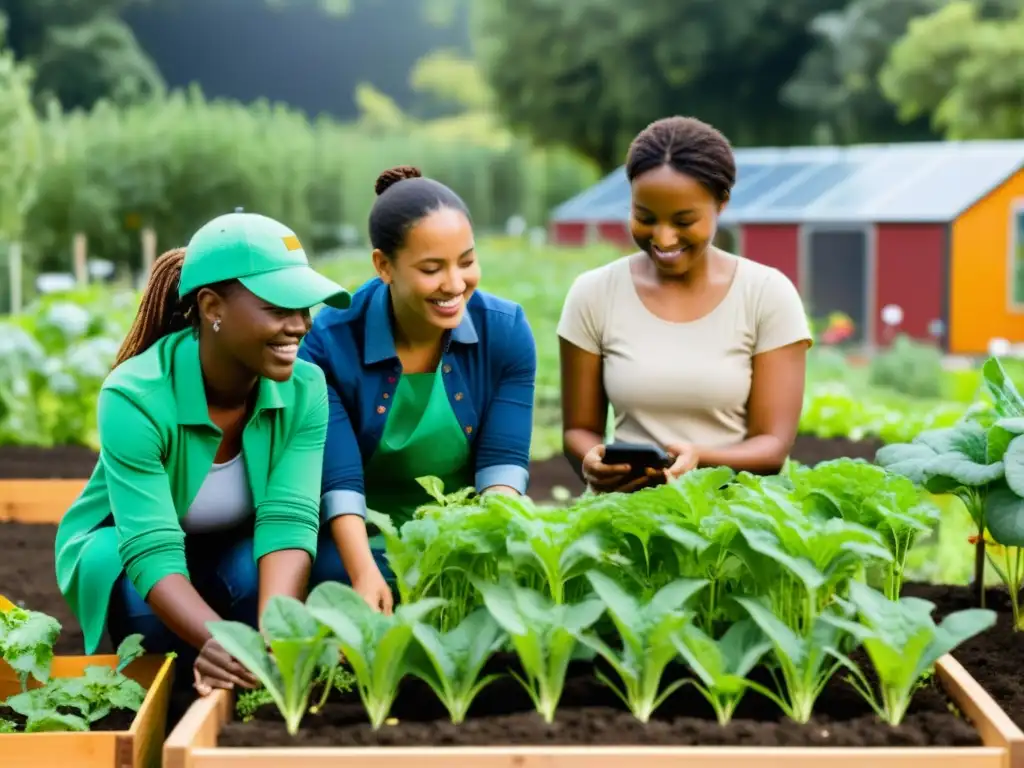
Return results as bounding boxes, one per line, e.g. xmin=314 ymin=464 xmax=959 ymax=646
xmin=552 ymin=141 xmax=1024 ymax=224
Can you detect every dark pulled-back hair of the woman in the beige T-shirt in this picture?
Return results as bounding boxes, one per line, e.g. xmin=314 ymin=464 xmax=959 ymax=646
xmin=626 ymin=116 xmax=736 ymax=203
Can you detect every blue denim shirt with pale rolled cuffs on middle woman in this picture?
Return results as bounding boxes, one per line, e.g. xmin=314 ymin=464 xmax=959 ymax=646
xmin=299 ymin=278 xmax=537 ymax=521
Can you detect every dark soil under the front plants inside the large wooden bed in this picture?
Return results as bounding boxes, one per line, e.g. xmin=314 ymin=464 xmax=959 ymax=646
xmin=218 ymin=656 xmax=980 ymax=746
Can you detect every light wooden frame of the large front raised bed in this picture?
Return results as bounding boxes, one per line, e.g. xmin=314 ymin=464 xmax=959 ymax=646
xmin=164 ymin=655 xmax=1024 ymax=768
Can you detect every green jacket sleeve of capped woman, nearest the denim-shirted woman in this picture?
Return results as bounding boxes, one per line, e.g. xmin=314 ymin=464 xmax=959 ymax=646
xmin=253 ymin=376 xmax=328 ymax=559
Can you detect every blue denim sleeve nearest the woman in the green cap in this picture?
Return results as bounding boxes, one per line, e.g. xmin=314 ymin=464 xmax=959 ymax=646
xmin=299 ymin=323 xmax=367 ymax=522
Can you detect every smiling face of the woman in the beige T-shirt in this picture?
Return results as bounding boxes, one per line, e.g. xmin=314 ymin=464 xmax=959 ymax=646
xmin=630 ymin=165 xmax=724 ymax=278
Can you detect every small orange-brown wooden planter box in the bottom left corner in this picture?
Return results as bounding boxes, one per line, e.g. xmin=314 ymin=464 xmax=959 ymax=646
xmin=0 ymin=654 xmax=174 ymax=768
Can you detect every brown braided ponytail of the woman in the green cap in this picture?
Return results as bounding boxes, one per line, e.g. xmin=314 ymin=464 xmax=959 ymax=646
xmin=114 ymin=248 xmax=237 ymax=368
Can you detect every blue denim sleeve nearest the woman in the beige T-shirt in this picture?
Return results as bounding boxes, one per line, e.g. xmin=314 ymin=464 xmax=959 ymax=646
xmin=475 ymin=307 xmax=537 ymax=494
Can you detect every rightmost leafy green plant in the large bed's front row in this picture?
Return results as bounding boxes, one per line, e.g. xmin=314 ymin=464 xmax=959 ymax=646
xmin=824 ymin=582 xmax=995 ymax=725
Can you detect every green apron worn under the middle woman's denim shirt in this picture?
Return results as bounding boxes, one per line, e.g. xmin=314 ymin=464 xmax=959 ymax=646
xmin=364 ymin=366 xmax=473 ymax=550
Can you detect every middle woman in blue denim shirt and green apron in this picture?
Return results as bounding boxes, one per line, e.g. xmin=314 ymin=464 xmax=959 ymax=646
xmin=299 ymin=166 xmax=537 ymax=612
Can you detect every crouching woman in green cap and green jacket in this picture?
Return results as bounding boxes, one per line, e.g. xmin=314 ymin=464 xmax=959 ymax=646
xmin=55 ymin=208 xmax=350 ymax=694
